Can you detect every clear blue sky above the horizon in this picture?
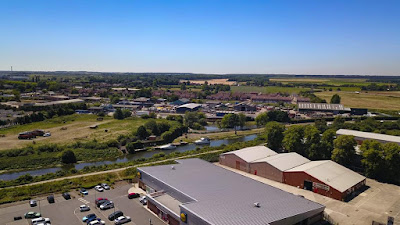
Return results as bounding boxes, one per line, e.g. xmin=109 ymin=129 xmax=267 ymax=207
xmin=0 ymin=0 xmax=400 ymax=75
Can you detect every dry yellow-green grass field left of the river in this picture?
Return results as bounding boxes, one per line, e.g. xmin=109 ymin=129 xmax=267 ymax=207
xmin=0 ymin=115 xmax=144 ymax=150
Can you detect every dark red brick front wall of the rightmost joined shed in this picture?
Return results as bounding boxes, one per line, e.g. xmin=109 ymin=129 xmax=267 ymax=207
xmin=283 ymin=172 xmax=345 ymax=201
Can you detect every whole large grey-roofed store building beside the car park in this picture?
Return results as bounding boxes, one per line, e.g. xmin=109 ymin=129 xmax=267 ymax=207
xmin=138 ymin=159 xmax=325 ymax=225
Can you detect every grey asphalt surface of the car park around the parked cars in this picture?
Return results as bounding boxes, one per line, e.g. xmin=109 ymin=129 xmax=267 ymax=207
xmin=0 ymin=184 xmax=165 ymax=225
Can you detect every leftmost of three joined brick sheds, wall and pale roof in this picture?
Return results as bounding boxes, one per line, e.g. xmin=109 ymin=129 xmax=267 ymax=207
xmin=219 ymin=146 xmax=278 ymax=173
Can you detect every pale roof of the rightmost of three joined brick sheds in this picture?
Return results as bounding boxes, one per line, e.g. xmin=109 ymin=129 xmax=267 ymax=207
xmin=286 ymin=160 xmax=365 ymax=192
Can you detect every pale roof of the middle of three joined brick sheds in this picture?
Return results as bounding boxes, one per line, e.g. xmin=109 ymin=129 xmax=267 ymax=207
xmin=252 ymin=152 xmax=310 ymax=171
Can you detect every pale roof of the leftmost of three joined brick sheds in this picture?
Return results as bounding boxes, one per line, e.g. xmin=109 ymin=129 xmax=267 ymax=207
xmin=222 ymin=145 xmax=278 ymax=162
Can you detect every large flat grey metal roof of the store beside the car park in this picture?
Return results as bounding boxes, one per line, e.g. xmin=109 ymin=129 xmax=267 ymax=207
xmin=138 ymin=159 xmax=324 ymax=225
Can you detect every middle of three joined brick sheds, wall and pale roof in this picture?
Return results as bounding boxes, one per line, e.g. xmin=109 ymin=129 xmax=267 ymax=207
xmin=250 ymin=152 xmax=310 ymax=183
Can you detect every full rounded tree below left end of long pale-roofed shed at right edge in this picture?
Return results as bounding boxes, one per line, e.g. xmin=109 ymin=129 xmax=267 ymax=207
xmin=332 ymin=135 xmax=357 ymax=166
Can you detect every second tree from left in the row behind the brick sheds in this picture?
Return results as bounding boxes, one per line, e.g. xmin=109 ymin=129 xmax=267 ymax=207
xmin=282 ymin=125 xmax=305 ymax=156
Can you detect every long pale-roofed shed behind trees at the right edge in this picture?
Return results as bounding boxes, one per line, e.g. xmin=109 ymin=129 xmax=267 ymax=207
xmin=336 ymin=129 xmax=400 ymax=145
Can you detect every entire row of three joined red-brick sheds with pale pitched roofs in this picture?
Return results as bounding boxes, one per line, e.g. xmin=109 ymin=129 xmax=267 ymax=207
xmin=219 ymin=146 xmax=366 ymax=201
